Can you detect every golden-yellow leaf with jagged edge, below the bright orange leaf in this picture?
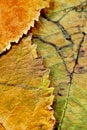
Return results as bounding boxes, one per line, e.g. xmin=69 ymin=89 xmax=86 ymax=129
xmin=0 ymin=36 xmax=55 ymax=130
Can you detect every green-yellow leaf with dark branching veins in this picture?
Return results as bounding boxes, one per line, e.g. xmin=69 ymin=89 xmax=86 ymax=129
xmin=32 ymin=0 xmax=87 ymax=130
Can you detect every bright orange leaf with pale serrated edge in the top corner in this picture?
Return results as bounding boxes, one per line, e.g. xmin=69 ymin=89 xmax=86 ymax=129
xmin=0 ymin=0 xmax=49 ymax=53
